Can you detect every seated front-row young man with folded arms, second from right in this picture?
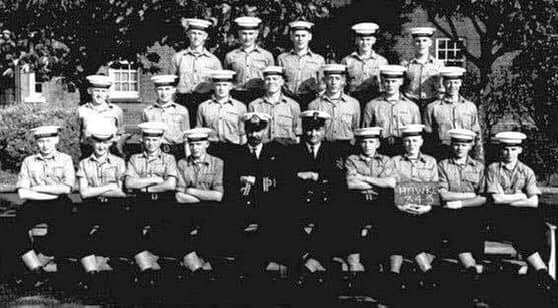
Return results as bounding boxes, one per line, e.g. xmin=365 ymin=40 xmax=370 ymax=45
xmin=437 ymin=128 xmax=486 ymax=281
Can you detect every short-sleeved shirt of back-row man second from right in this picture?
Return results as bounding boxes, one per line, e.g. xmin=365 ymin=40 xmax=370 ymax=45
xmin=341 ymin=52 xmax=388 ymax=93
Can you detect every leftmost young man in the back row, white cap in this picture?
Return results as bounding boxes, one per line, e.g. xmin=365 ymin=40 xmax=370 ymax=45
xmin=170 ymin=18 xmax=222 ymax=127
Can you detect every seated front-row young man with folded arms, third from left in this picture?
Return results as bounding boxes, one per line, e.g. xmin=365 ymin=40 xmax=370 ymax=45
xmin=125 ymin=122 xmax=177 ymax=285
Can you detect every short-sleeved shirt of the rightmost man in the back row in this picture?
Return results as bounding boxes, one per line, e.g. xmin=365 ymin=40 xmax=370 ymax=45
xmin=401 ymin=56 xmax=444 ymax=100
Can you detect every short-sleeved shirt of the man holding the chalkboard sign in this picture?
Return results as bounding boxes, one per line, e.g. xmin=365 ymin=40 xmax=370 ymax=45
xmin=386 ymin=154 xmax=438 ymax=182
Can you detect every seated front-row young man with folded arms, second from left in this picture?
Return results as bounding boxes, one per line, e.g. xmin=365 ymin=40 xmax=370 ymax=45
xmin=76 ymin=124 xmax=127 ymax=289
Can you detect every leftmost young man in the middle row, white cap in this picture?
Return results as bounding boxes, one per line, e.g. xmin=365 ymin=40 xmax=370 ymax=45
xmin=78 ymin=75 xmax=125 ymax=158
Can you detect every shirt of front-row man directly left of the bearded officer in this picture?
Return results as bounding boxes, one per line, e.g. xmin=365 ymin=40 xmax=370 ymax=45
xmin=176 ymin=154 xmax=223 ymax=192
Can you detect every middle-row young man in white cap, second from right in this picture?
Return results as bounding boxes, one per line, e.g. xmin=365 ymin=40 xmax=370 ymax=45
xmin=362 ymin=65 xmax=420 ymax=156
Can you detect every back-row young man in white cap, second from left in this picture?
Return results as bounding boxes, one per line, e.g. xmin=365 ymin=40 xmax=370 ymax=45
xmin=224 ymin=16 xmax=275 ymax=105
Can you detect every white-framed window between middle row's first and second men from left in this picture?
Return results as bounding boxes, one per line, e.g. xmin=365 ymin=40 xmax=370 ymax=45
xmin=108 ymin=61 xmax=140 ymax=101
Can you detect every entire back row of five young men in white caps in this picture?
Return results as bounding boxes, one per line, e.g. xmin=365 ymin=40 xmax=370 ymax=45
xmin=169 ymin=16 xmax=444 ymax=114
